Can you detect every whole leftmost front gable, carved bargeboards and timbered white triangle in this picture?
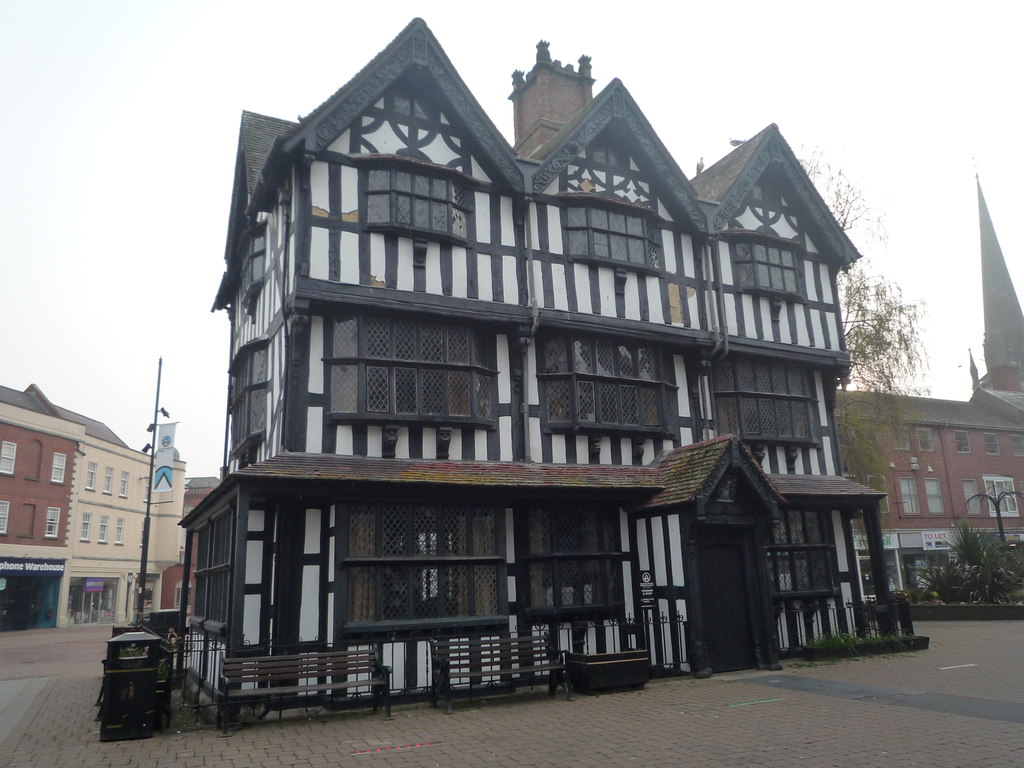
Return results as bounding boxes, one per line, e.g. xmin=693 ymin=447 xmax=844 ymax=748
xmin=282 ymin=18 xmax=523 ymax=190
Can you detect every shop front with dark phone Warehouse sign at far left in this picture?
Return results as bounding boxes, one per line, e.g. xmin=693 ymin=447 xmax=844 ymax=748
xmin=0 ymin=557 xmax=65 ymax=632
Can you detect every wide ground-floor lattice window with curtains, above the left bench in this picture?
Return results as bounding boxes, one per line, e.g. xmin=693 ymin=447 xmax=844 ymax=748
xmin=344 ymin=505 xmax=505 ymax=624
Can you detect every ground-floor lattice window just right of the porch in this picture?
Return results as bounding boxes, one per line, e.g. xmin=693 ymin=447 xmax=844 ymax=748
xmin=766 ymin=510 xmax=835 ymax=594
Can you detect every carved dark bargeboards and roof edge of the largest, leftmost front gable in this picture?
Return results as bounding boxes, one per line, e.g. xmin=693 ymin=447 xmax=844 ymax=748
xmin=264 ymin=18 xmax=523 ymax=190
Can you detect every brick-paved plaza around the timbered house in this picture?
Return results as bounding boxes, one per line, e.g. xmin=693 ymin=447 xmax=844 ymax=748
xmin=0 ymin=622 xmax=1024 ymax=768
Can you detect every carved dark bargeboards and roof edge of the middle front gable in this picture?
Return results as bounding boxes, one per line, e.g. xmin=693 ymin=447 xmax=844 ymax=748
xmin=530 ymin=78 xmax=708 ymax=232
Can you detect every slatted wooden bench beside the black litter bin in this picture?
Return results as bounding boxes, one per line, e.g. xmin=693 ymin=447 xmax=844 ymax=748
xmin=218 ymin=650 xmax=391 ymax=733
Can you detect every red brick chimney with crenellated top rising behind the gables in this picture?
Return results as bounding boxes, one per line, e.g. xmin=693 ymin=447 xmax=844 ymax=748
xmin=509 ymin=40 xmax=594 ymax=158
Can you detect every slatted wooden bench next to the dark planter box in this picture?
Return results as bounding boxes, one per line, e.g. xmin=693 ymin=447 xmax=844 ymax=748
xmin=430 ymin=635 xmax=575 ymax=715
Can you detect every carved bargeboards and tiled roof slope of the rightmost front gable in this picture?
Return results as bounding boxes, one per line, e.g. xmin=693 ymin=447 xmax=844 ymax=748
xmin=692 ymin=123 xmax=860 ymax=264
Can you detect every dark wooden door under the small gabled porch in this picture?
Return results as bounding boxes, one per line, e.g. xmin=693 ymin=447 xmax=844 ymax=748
xmin=697 ymin=526 xmax=757 ymax=672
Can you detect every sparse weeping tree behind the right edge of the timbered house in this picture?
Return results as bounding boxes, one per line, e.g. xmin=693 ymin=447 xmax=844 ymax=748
xmin=803 ymin=151 xmax=927 ymax=482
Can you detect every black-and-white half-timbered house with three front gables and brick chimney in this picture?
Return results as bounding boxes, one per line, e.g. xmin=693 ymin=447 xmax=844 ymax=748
xmin=183 ymin=19 xmax=887 ymax=694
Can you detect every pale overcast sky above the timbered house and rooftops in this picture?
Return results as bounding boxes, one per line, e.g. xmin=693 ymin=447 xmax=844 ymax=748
xmin=0 ymin=0 xmax=1024 ymax=476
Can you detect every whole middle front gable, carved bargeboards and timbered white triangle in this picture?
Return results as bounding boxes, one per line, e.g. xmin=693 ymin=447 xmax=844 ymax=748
xmin=532 ymin=80 xmax=708 ymax=232
